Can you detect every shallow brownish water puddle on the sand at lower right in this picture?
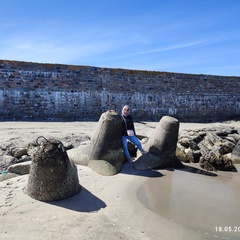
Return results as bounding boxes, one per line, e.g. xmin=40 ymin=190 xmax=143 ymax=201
xmin=138 ymin=170 xmax=240 ymax=239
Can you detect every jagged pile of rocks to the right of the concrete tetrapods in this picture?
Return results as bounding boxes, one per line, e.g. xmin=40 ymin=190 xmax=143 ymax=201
xmin=176 ymin=125 xmax=240 ymax=171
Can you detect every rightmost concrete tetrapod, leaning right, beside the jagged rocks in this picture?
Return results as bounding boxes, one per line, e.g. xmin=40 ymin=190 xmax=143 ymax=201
xmin=134 ymin=116 xmax=183 ymax=170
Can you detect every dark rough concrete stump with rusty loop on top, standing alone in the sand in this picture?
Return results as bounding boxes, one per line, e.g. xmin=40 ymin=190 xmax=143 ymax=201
xmin=26 ymin=138 xmax=81 ymax=201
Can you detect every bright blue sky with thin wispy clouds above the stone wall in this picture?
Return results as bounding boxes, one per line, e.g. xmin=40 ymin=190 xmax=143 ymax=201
xmin=0 ymin=0 xmax=240 ymax=76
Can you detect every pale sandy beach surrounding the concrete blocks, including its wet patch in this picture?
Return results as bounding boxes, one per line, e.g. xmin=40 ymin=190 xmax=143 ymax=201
xmin=0 ymin=122 xmax=240 ymax=240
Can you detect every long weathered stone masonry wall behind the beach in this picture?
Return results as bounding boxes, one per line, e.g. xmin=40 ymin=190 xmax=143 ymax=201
xmin=0 ymin=60 xmax=240 ymax=122
